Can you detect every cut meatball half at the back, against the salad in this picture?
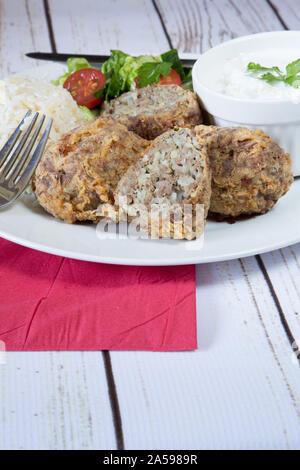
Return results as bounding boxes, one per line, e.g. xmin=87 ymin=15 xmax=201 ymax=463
xmin=102 ymin=85 xmax=202 ymax=140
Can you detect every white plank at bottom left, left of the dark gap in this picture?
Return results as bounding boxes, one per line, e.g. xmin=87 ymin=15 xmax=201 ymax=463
xmin=0 ymin=352 xmax=116 ymax=450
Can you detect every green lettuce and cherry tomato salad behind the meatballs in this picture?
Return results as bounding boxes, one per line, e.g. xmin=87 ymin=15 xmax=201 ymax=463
xmin=53 ymin=49 xmax=192 ymax=120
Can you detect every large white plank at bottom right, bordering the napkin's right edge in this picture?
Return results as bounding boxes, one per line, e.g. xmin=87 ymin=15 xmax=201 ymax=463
xmin=112 ymin=258 xmax=300 ymax=449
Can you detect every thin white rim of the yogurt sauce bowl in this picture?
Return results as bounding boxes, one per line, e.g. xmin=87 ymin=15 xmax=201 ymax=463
xmin=192 ymin=30 xmax=300 ymax=107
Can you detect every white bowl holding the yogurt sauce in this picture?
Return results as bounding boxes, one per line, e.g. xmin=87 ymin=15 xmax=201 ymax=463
xmin=193 ymin=31 xmax=300 ymax=175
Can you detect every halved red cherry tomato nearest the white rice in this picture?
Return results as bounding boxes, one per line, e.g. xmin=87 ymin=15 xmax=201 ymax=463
xmin=64 ymin=67 xmax=106 ymax=109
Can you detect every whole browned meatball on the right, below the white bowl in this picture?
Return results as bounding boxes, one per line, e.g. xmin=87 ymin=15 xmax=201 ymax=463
xmin=195 ymin=126 xmax=293 ymax=217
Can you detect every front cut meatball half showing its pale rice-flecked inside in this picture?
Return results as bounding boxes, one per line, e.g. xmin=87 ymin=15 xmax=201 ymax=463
xmin=111 ymin=128 xmax=211 ymax=239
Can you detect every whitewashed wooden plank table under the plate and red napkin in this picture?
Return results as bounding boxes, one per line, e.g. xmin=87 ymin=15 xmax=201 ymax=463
xmin=0 ymin=0 xmax=300 ymax=449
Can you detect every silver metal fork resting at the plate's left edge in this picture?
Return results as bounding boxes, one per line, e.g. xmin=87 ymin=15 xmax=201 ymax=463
xmin=0 ymin=111 xmax=53 ymax=208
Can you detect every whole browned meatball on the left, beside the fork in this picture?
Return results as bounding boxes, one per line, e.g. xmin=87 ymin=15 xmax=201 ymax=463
xmin=33 ymin=119 xmax=149 ymax=223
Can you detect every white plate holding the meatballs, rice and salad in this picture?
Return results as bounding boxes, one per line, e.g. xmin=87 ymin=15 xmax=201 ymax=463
xmin=0 ymin=61 xmax=300 ymax=266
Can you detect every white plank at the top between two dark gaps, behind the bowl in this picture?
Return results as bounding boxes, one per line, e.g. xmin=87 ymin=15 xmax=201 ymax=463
xmin=155 ymin=0 xmax=283 ymax=52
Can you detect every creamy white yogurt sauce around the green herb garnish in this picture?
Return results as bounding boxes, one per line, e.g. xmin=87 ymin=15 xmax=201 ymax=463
xmin=215 ymin=48 xmax=300 ymax=104
